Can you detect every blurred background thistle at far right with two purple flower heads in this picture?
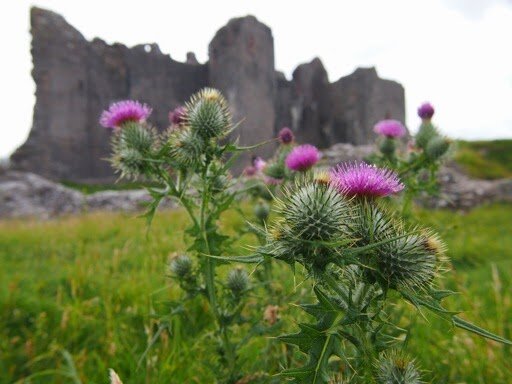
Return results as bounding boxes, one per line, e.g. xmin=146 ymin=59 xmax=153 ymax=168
xmin=368 ymin=103 xmax=452 ymax=215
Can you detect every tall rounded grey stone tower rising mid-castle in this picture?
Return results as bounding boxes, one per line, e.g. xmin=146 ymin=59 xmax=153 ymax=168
xmin=208 ymin=16 xmax=276 ymax=168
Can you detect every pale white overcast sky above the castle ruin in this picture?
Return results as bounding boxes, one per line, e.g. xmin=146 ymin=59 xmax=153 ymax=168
xmin=0 ymin=0 xmax=512 ymax=157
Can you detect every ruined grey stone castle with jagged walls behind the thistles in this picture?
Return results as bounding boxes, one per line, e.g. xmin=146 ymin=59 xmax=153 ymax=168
xmin=11 ymin=8 xmax=405 ymax=182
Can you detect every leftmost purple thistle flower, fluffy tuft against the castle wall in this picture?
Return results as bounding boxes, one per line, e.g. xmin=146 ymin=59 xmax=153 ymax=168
xmin=100 ymin=100 xmax=152 ymax=128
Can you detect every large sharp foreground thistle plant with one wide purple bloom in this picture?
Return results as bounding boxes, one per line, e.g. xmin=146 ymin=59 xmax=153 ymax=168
xmin=233 ymin=163 xmax=512 ymax=384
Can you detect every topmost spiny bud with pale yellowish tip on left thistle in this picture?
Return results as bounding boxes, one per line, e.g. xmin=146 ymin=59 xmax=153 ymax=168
xmin=186 ymin=88 xmax=231 ymax=139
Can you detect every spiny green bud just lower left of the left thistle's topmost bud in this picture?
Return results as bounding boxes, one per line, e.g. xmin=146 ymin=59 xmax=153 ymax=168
xmin=168 ymin=127 xmax=206 ymax=168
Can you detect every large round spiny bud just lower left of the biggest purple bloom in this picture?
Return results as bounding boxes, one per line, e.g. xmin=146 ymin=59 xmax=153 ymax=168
xmin=278 ymin=183 xmax=350 ymax=241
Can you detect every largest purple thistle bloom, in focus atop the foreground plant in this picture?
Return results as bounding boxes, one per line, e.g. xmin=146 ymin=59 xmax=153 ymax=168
xmin=331 ymin=162 xmax=404 ymax=197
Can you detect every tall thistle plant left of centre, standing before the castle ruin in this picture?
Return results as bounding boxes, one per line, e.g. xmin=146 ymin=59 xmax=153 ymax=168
xmin=100 ymin=88 xmax=270 ymax=383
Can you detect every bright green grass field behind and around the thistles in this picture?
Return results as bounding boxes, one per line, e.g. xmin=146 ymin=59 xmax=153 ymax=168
xmin=0 ymin=205 xmax=512 ymax=384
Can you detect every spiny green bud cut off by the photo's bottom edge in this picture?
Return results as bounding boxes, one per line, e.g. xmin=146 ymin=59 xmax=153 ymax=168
xmin=375 ymin=351 xmax=422 ymax=384
